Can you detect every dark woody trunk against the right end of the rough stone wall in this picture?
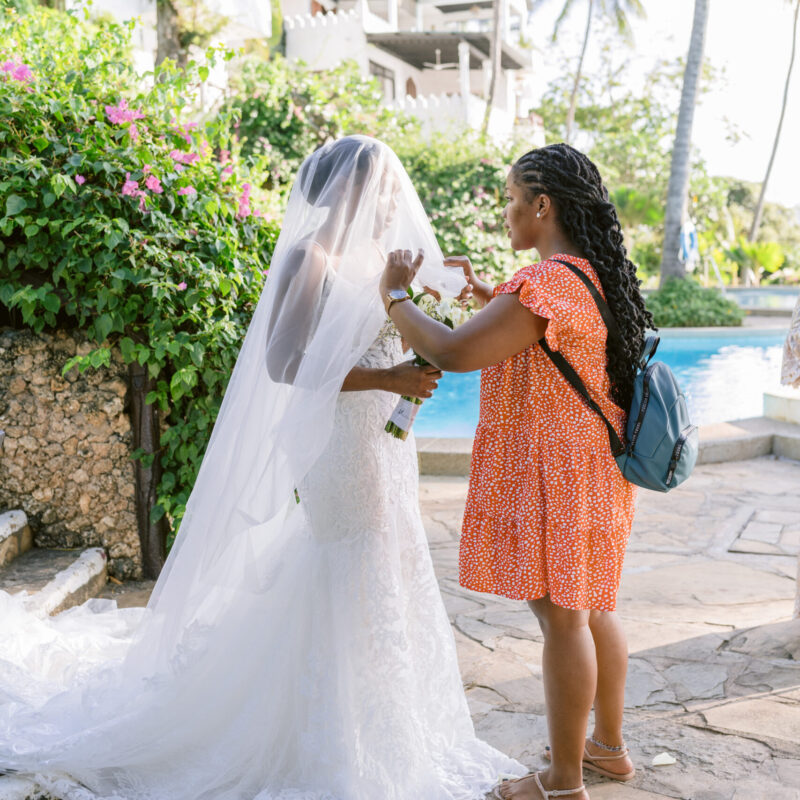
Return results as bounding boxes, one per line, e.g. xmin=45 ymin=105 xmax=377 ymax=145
xmin=128 ymin=363 xmax=167 ymax=578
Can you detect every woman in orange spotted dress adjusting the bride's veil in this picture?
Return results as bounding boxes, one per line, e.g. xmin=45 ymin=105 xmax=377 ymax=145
xmin=381 ymin=144 xmax=652 ymax=800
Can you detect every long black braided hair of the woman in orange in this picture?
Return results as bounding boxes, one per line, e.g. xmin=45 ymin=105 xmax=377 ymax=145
xmin=511 ymin=144 xmax=654 ymax=411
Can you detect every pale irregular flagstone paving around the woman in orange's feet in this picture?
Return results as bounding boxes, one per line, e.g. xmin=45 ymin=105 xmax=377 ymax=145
xmin=421 ymin=456 xmax=800 ymax=800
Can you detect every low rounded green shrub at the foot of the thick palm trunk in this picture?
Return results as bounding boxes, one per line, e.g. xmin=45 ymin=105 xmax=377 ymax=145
xmin=647 ymin=278 xmax=744 ymax=328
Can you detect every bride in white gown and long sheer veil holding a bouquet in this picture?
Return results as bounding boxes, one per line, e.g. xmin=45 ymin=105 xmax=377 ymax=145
xmin=0 ymin=136 xmax=525 ymax=800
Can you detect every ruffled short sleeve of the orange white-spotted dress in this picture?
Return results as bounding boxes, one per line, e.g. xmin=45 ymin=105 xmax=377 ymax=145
xmin=495 ymin=261 xmax=594 ymax=350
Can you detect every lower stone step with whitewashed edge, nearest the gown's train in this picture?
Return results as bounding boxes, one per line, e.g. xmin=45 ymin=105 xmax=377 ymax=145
xmin=0 ymin=547 xmax=108 ymax=617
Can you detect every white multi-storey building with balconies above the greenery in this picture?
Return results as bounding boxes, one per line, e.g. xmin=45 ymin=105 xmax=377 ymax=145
xmin=282 ymin=0 xmax=544 ymax=145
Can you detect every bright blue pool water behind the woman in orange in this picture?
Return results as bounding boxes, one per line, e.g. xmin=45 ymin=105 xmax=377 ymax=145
xmin=414 ymin=328 xmax=786 ymax=437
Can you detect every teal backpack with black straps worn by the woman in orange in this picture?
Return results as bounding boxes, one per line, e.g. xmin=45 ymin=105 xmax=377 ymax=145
xmin=539 ymin=259 xmax=698 ymax=492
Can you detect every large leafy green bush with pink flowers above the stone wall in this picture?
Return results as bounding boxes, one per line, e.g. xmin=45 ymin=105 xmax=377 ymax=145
xmin=0 ymin=7 xmax=278 ymax=528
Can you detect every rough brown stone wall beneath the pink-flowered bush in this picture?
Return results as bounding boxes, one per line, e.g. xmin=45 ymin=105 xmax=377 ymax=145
xmin=0 ymin=329 xmax=141 ymax=578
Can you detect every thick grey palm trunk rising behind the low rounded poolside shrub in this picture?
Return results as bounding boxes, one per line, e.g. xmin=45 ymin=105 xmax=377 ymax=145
xmin=661 ymin=0 xmax=709 ymax=286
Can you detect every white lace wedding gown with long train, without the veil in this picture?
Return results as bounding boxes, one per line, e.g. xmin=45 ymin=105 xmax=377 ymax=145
xmin=0 ymin=323 xmax=526 ymax=800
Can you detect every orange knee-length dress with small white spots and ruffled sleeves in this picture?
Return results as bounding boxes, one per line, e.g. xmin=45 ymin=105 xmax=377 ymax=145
xmin=459 ymin=254 xmax=635 ymax=611
